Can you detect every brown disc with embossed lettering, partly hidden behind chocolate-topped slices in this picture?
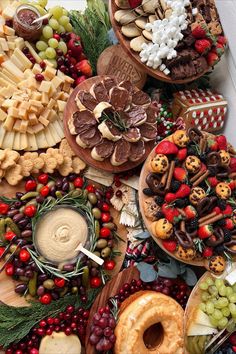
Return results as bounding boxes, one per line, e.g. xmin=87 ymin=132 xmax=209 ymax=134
xmin=97 ymin=44 xmax=147 ymax=89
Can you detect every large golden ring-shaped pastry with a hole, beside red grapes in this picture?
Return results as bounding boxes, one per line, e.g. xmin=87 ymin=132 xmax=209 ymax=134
xmin=114 ymin=290 xmax=184 ymax=354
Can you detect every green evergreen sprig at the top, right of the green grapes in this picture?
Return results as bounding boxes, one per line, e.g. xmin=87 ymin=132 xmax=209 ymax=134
xmin=70 ymin=0 xmax=111 ymax=75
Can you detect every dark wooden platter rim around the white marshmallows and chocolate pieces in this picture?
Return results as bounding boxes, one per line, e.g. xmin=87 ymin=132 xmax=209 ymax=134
xmin=109 ymin=0 xmax=210 ymax=84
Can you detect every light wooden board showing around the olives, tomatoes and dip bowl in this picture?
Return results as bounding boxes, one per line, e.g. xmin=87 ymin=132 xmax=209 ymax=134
xmin=0 ymin=181 xmax=127 ymax=306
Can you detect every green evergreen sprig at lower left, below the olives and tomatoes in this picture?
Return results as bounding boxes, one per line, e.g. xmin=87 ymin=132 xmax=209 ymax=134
xmin=0 ymin=289 xmax=99 ymax=349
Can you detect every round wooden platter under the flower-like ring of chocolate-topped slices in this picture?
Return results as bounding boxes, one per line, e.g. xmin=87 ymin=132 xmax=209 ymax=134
xmin=64 ymin=75 xmax=154 ymax=173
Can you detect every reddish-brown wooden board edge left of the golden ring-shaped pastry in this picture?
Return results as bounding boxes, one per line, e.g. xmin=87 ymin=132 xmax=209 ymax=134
xmin=85 ymin=267 xmax=139 ymax=354
